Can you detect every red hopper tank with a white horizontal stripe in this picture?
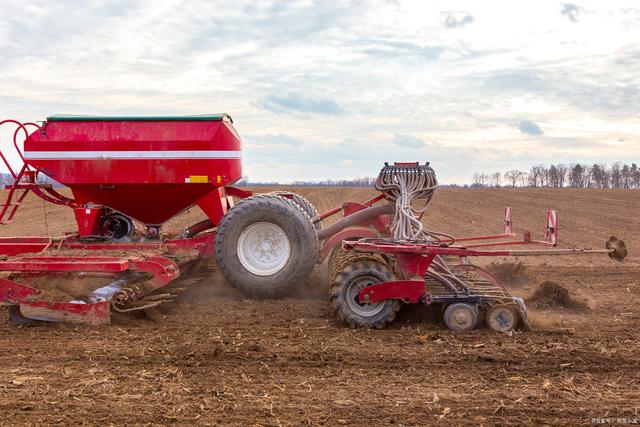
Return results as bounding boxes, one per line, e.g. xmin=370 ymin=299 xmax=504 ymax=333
xmin=24 ymin=120 xmax=242 ymax=224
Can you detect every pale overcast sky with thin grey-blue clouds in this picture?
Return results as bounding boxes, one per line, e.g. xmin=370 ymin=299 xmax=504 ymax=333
xmin=0 ymin=0 xmax=640 ymax=183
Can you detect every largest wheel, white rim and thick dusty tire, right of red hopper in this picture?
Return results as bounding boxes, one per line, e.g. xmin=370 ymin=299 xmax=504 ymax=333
xmin=215 ymin=194 xmax=318 ymax=298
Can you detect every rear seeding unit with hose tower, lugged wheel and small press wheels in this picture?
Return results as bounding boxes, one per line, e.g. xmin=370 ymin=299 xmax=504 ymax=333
xmin=329 ymin=163 xmax=627 ymax=332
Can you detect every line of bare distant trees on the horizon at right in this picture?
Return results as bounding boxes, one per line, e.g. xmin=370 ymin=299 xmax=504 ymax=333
xmin=471 ymin=162 xmax=640 ymax=188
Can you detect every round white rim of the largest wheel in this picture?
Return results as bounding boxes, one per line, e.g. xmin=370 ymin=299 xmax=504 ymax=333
xmin=237 ymin=221 xmax=291 ymax=276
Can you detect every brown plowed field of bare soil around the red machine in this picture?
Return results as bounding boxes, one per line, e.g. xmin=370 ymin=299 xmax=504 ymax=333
xmin=0 ymin=188 xmax=640 ymax=426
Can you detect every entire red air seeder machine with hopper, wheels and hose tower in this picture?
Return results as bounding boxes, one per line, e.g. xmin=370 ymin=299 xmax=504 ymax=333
xmin=0 ymin=114 xmax=626 ymax=330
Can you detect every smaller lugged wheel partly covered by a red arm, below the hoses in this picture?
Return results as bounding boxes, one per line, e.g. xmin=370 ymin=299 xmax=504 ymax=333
xmin=329 ymin=258 xmax=402 ymax=329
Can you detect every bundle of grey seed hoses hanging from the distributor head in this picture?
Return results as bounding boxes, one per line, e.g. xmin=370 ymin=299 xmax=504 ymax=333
xmin=376 ymin=162 xmax=454 ymax=244
